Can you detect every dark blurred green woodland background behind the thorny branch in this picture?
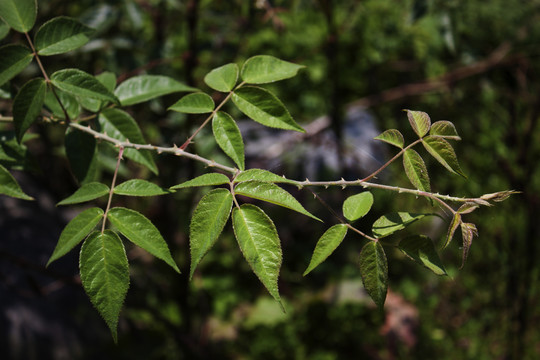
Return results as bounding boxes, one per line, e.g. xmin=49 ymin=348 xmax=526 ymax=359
xmin=0 ymin=0 xmax=540 ymax=360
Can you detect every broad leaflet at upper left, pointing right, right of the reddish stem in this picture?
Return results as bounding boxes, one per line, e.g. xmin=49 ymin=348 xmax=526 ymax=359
xmin=34 ymin=16 xmax=94 ymax=56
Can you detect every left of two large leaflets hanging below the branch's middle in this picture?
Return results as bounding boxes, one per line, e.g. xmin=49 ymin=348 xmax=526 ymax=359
xmin=189 ymin=189 xmax=233 ymax=279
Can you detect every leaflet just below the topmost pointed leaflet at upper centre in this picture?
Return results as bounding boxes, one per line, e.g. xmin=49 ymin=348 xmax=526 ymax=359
xmin=232 ymin=86 xmax=305 ymax=132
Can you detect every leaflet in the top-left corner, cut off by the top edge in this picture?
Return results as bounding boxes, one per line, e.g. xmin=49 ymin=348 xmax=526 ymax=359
xmin=0 ymin=0 xmax=37 ymax=33
